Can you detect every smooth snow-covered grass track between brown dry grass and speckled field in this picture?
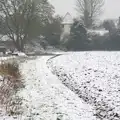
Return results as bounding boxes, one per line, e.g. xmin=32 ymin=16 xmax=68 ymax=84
xmin=20 ymin=56 xmax=97 ymax=120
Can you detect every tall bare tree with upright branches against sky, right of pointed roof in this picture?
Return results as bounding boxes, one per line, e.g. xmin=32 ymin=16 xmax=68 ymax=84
xmin=76 ymin=0 xmax=104 ymax=27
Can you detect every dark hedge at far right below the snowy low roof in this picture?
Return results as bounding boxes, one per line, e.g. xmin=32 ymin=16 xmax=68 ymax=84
xmin=89 ymin=31 xmax=120 ymax=51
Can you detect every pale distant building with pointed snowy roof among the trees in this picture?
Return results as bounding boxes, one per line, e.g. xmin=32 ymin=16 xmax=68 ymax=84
xmin=61 ymin=12 xmax=73 ymax=40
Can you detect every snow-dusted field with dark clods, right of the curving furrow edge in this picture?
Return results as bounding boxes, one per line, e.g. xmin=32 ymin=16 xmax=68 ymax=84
xmin=48 ymin=52 xmax=120 ymax=120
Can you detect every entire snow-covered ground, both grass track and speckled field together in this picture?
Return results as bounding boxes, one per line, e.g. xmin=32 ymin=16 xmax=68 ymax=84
xmin=0 ymin=52 xmax=120 ymax=120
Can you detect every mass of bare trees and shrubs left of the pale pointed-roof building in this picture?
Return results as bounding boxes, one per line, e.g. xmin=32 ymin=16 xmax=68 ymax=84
xmin=0 ymin=0 xmax=61 ymax=51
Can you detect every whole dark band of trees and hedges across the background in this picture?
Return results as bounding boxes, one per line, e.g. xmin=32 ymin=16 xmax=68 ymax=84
xmin=0 ymin=0 xmax=120 ymax=51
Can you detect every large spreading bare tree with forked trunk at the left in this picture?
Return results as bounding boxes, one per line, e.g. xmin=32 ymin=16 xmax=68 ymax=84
xmin=0 ymin=0 xmax=53 ymax=51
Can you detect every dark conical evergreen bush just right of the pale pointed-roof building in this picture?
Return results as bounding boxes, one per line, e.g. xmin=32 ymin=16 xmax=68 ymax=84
xmin=65 ymin=20 xmax=88 ymax=51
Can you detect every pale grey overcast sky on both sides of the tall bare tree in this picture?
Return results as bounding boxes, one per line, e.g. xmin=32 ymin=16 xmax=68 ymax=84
xmin=49 ymin=0 xmax=120 ymax=19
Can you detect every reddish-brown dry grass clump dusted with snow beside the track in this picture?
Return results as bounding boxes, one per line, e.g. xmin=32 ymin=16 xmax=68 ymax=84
xmin=0 ymin=61 xmax=24 ymax=115
